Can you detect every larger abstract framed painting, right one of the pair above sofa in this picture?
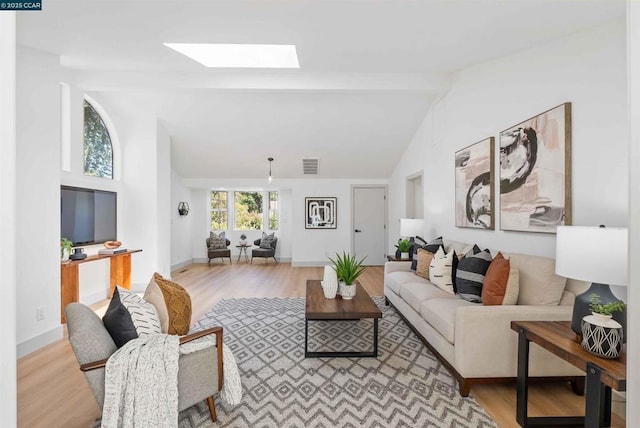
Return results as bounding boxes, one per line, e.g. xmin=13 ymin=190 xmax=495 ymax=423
xmin=500 ymin=103 xmax=571 ymax=233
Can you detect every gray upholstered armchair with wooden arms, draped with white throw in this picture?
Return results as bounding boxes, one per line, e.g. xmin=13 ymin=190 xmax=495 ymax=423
xmin=64 ymin=303 xmax=222 ymax=422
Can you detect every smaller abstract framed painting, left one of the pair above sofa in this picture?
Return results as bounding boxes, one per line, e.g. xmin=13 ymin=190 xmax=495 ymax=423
xmin=455 ymin=137 xmax=495 ymax=230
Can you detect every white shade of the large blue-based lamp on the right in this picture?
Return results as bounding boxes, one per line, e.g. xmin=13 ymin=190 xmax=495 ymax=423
xmin=556 ymin=226 xmax=629 ymax=285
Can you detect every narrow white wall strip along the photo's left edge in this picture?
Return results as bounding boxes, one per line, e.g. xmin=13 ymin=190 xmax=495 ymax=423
xmin=0 ymin=11 xmax=17 ymax=427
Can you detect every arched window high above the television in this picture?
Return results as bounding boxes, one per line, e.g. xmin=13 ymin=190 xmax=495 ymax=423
xmin=84 ymin=100 xmax=113 ymax=179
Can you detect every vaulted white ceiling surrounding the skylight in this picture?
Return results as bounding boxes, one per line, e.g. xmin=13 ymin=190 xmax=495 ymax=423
xmin=18 ymin=0 xmax=625 ymax=178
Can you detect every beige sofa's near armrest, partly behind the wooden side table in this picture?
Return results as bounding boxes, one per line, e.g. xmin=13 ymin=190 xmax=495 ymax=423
xmin=454 ymin=305 xmax=580 ymax=377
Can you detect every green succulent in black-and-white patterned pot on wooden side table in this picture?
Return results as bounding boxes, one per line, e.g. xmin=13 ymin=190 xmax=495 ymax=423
xmin=581 ymin=293 xmax=627 ymax=358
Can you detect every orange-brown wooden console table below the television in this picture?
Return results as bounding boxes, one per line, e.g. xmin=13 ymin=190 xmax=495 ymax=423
xmin=60 ymin=250 xmax=142 ymax=323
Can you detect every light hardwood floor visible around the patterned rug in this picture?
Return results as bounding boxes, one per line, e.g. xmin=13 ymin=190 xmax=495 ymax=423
xmin=18 ymin=259 xmax=625 ymax=428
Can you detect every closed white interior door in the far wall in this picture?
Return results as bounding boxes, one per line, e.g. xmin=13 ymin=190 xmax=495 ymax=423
xmin=353 ymin=187 xmax=387 ymax=266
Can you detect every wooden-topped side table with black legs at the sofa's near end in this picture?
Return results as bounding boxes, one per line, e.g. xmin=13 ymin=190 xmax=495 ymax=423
xmin=511 ymin=321 xmax=627 ymax=428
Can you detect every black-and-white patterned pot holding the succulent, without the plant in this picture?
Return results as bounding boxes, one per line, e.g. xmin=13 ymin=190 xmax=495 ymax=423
xmin=581 ymin=313 xmax=623 ymax=358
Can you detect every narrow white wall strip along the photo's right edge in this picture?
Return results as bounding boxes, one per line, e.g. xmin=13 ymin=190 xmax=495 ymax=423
xmin=626 ymin=2 xmax=640 ymax=427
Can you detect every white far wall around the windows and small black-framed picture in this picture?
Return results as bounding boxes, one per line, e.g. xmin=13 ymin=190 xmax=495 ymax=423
xmin=182 ymin=179 xmax=388 ymax=266
